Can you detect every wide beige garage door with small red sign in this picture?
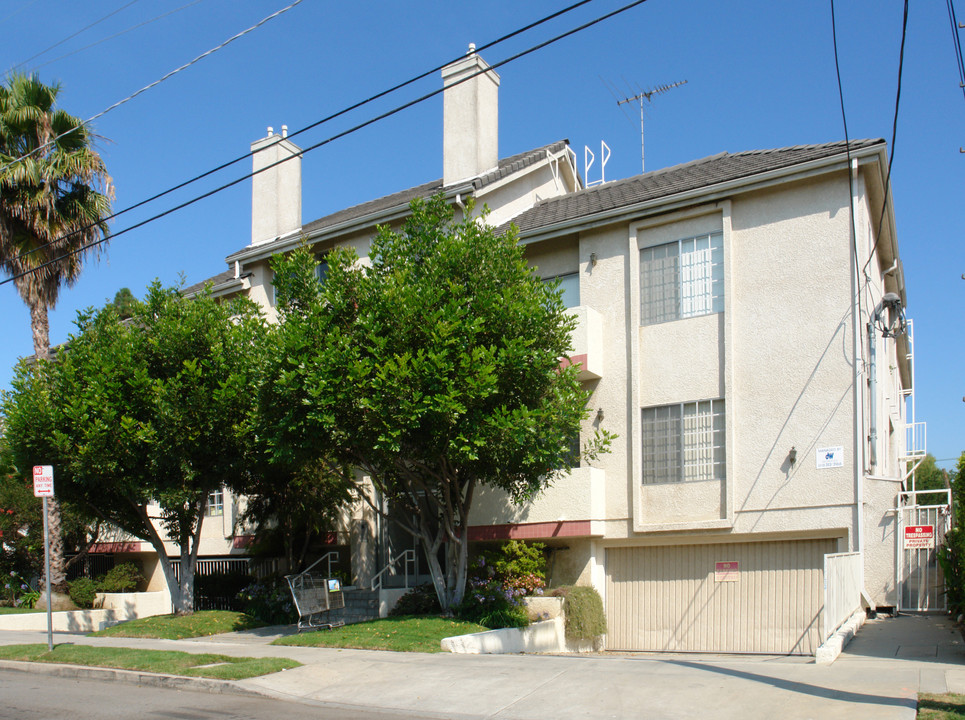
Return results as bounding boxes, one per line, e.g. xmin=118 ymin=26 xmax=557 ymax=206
xmin=606 ymin=539 xmax=836 ymax=655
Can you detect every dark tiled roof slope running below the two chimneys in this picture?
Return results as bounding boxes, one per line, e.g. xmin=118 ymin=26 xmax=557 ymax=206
xmin=228 ymin=140 xmax=569 ymax=258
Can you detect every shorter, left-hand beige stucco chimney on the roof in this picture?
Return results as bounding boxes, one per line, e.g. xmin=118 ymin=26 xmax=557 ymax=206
xmin=251 ymin=125 xmax=302 ymax=245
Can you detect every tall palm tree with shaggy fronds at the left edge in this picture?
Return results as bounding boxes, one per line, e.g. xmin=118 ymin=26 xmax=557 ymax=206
xmin=0 ymin=73 xmax=113 ymax=592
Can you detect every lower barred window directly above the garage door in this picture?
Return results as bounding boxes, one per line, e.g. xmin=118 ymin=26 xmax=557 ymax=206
xmin=643 ymin=400 xmax=727 ymax=485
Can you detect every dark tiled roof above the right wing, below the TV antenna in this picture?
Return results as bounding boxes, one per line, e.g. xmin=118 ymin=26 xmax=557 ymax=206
xmin=513 ymin=138 xmax=885 ymax=234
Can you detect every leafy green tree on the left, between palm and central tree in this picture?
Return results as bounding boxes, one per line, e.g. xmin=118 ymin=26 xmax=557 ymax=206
xmin=3 ymin=283 xmax=265 ymax=613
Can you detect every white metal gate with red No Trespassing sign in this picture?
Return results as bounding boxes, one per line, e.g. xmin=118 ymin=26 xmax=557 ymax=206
xmin=897 ymin=490 xmax=951 ymax=611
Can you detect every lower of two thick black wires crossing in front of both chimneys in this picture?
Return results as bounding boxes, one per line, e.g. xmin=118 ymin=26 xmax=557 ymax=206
xmin=0 ymin=0 xmax=647 ymax=285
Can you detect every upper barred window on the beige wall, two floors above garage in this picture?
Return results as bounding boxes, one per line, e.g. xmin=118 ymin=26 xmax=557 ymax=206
xmin=640 ymin=232 xmax=724 ymax=325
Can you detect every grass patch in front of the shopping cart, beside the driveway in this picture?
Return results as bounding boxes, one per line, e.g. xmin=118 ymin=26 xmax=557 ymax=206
xmin=272 ymin=617 xmax=486 ymax=652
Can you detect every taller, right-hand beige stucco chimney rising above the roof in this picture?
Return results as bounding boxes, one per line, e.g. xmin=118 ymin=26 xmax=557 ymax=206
xmin=442 ymin=44 xmax=499 ymax=185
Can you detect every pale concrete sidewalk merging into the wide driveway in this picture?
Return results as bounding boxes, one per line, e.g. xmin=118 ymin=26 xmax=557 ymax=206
xmin=0 ymin=616 xmax=965 ymax=720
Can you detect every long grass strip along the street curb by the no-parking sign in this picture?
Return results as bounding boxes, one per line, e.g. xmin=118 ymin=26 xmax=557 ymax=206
xmin=0 ymin=644 xmax=301 ymax=680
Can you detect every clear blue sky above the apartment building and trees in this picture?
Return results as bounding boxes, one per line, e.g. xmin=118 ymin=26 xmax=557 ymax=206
xmin=0 ymin=0 xmax=965 ymax=466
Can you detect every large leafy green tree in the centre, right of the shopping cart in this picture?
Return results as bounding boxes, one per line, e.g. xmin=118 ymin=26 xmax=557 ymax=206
xmin=258 ymin=197 xmax=609 ymax=609
